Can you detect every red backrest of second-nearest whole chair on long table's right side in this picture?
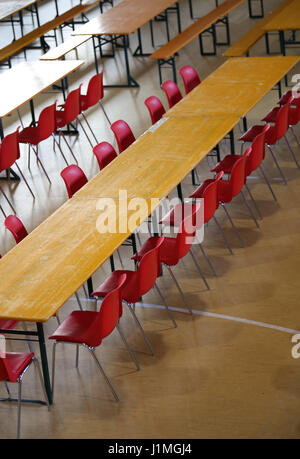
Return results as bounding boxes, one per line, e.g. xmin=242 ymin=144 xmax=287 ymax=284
xmin=138 ymin=236 xmax=165 ymax=296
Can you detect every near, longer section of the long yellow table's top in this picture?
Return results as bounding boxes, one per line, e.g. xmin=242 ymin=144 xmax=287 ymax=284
xmin=0 ymin=116 xmax=239 ymax=322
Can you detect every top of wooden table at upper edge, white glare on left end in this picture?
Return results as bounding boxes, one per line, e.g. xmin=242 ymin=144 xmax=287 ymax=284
xmin=72 ymin=0 xmax=178 ymax=35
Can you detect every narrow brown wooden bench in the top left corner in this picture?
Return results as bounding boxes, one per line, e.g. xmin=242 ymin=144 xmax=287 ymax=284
xmin=0 ymin=0 xmax=101 ymax=67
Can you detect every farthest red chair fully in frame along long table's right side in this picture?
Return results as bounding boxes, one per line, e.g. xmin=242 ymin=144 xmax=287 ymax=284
xmin=239 ymin=98 xmax=300 ymax=185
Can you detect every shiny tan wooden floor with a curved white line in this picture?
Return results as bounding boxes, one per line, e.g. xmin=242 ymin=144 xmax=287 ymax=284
xmin=0 ymin=0 xmax=300 ymax=439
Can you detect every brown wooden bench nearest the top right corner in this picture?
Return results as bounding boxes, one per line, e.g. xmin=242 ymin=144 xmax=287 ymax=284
xmin=223 ymin=0 xmax=292 ymax=57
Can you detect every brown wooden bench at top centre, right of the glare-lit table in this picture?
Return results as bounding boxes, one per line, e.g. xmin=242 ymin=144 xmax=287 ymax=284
xmin=150 ymin=0 xmax=244 ymax=84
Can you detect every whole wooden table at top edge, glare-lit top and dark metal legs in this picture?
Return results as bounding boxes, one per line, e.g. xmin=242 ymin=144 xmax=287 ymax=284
xmin=72 ymin=0 xmax=180 ymax=87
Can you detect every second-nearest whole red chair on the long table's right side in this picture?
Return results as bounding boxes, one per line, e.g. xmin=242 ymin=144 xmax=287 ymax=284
xmin=92 ymin=237 xmax=177 ymax=348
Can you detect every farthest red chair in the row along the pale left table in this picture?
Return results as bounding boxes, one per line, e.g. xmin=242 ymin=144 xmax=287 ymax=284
xmin=80 ymin=70 xmax=111 ymax=143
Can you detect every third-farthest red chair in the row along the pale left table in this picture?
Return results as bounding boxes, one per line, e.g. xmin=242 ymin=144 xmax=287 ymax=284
xmin=19 ymin=101 xmax=68 ymax=183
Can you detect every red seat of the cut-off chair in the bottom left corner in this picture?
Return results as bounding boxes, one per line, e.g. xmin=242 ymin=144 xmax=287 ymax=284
xmin=0 ymin=352 xmax=34 ymax=382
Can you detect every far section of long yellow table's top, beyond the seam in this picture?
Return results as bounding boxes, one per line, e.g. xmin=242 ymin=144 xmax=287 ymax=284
xmin=165 ymin=56 xmax=300 ymax=117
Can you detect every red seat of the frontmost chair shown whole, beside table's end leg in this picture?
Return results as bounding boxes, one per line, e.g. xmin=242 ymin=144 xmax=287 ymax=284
xmin=49 ymin=311 xmax=99 ymax=347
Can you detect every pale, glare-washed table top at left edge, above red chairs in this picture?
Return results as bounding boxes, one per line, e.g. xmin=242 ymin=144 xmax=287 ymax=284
xmin=0 ymin=60 xmax=84 ymax=118
